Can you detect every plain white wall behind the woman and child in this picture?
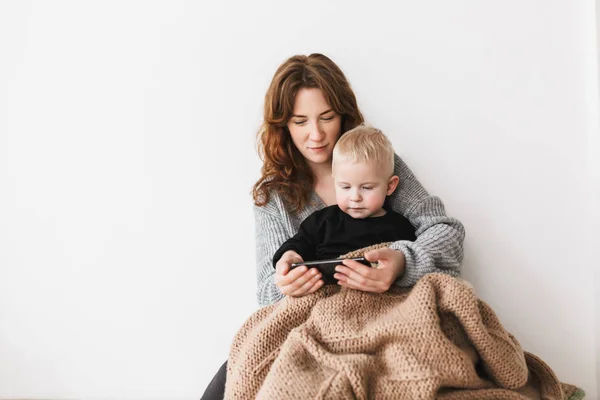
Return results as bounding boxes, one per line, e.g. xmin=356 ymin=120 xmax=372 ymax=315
xmin=0 ymin=0 xmax=600 ymax=399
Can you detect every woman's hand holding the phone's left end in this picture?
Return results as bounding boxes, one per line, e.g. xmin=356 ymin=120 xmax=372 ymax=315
xmin=275 ymin=250 xmax=323 ymax=297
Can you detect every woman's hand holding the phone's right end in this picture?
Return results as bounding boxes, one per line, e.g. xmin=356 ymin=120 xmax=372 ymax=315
xmin=333 ymin=248 xmax=406 ymax=293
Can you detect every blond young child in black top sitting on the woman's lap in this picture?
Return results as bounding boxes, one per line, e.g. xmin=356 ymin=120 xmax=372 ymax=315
xmin=273 ymin=125 xmax=416 ymax=284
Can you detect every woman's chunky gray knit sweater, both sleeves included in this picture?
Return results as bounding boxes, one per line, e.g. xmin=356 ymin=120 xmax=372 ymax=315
xmin=254 ymin=155 xmax=465 ymax=306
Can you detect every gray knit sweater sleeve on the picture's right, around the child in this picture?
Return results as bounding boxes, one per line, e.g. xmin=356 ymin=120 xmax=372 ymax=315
xmin=390 ymin=155 xmax=465 ymax=287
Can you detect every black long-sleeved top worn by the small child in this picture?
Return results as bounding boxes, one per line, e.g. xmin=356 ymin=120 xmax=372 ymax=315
xmin=273 ymin=205 xmax=416 ymax=267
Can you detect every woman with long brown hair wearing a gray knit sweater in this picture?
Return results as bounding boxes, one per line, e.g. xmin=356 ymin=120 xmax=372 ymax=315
xmin=203 ymin=54 xmax=464 ymax=399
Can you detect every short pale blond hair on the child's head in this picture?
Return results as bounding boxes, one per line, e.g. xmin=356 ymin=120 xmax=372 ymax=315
xmin=332 ymin=124 xmax=394 ymax=177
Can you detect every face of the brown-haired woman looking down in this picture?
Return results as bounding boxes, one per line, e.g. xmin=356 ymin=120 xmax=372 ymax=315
xmin=287 ymin=88 xmax=342 ymax=166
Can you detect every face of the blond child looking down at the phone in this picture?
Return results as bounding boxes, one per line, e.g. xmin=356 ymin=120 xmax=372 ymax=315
xmin=333 ymin=162 xmax=398 ymax=219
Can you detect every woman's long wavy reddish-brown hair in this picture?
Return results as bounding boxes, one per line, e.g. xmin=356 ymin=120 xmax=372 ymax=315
xmin=252 ymin=53 xmax=364 ymax=213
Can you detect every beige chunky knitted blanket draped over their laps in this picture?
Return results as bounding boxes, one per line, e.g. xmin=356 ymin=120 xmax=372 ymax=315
xmin=225 ymin=274 xmax=583 ymax=400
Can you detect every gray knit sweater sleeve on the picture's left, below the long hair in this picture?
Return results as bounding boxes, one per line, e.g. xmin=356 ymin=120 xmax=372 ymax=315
xmin=254 ymin=204 xmax=289 ymax=307
